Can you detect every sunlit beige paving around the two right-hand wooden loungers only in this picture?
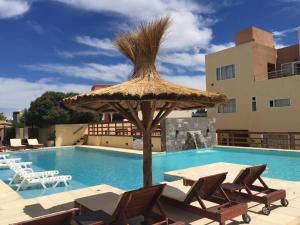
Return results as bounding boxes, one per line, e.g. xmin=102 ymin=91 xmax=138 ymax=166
xmin=165 ymin=163 xmax=300 ymax=225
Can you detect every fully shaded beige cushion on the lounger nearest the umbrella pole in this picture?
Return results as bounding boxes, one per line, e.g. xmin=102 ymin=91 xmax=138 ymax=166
xmin=76 ymin=192 xmax=122 ymax=215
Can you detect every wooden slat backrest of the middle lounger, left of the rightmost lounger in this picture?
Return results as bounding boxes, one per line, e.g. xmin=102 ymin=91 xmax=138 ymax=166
xmin=184 ymin=173 xmax=227 ymax=204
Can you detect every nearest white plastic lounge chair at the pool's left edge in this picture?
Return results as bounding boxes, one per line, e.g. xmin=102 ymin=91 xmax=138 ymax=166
xmin=17 ymin=176 xmax=72 ymax=191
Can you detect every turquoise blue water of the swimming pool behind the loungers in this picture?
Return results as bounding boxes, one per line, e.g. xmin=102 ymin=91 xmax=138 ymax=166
xmin=0 ymin=147 xmax=300 ymax=198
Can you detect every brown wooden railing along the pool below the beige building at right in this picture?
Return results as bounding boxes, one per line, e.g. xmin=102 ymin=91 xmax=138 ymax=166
xmin=217 ymin=130 xmax=300 ymax=149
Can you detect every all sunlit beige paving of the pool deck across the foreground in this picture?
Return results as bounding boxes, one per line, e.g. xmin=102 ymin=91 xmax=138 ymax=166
xmin=0 ymin=163 xmax=300 ymax=225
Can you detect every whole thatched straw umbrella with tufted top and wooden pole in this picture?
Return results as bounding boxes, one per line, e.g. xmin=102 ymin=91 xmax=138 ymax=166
xmin=64 ymin=18 xmax=226 ymax=186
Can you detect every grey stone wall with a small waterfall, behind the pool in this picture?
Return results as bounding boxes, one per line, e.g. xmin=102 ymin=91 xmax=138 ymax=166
xmin=161 ymin=117 xmax=216 ymax=151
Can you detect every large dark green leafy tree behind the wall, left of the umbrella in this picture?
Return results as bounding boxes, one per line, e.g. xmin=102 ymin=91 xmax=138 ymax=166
xmin=24 ymin=92 xmax=102 ymax=127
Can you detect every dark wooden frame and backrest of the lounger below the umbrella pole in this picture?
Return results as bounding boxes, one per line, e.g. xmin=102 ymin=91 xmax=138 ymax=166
xmin=74 ymin=184 xmax=184 ymax=225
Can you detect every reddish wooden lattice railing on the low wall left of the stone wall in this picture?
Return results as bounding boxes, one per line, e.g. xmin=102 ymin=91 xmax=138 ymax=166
xmin=88 ymin=122 xmax=161 ymax=137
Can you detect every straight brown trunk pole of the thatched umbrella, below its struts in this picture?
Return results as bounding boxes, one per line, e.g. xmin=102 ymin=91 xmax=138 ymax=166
xmin=143 ymin=129 xmax=152 ymax=187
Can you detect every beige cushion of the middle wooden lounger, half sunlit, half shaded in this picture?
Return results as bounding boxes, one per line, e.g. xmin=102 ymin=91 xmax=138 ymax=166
xmin=162 ymin=180 xmax=191 ymax=202
